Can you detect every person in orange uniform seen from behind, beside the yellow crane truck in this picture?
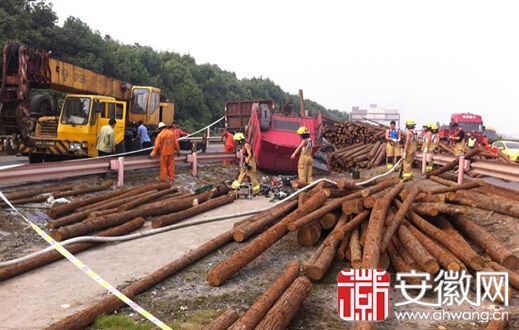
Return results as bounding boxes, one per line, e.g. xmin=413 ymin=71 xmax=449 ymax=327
xmin=150 ymin=122 xmax=180 ymax=182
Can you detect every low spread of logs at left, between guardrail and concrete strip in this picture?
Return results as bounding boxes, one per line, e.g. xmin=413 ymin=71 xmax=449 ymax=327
xmin=0 ymin=182 xmax=235 ymax=281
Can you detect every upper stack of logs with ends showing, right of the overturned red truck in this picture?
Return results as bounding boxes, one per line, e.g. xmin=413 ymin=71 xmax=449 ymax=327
xmin=323 ymin=122 xmax=385 ymax=149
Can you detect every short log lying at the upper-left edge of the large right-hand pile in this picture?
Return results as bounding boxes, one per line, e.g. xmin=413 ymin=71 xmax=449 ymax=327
xmin=234 ymin=201 xmax=298 ymax=242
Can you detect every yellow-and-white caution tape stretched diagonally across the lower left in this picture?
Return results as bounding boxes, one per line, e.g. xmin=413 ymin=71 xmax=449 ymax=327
xmin=0 ymin=191 xmax=172 ymax=330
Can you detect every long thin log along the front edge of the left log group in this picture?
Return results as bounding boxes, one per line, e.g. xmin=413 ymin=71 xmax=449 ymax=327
xmin=51 ymin=191 xmax=211 ymax=241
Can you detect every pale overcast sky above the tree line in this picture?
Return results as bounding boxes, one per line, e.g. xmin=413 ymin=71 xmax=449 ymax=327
xmin=50 ymin=0 xmax=519 ymax=137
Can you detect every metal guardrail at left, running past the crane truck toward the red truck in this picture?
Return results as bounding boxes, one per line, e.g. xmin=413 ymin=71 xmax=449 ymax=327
xmin=0 ymin=152 xmax=237 ymax=187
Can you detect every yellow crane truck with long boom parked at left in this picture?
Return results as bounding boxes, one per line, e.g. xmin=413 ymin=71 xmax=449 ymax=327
xmin=0 ymin=43 xmax=174 ymax=162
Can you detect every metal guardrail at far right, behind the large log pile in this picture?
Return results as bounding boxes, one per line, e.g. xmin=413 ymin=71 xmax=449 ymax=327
xmin=416 ymin=153 xmax=519 ymax=182
